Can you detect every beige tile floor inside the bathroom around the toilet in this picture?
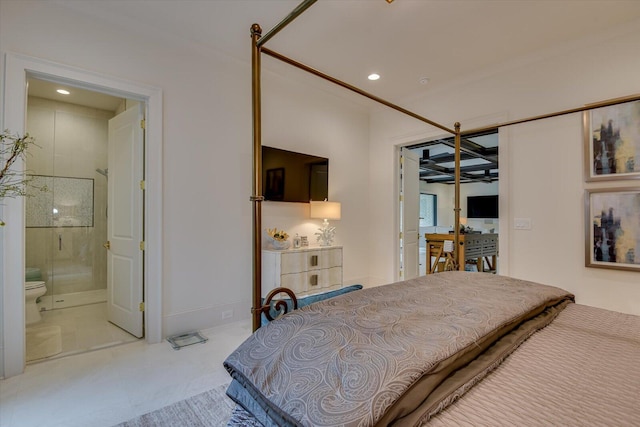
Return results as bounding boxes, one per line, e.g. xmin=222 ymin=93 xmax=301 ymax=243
xmin=27 ymin=302 xmax=138 ymax=363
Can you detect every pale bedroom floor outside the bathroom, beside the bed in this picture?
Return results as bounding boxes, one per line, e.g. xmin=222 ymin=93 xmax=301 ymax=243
xmin=0 ymin=319 xmax=251 ymax=427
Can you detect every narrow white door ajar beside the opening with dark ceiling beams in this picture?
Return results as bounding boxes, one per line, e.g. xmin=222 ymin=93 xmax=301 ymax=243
xmin=400 ymin=148 xmax=420 ymax=280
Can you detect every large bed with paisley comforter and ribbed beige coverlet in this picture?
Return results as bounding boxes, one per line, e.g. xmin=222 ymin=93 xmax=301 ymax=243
xmin=224 ymin=271 xmax=640 ymax=426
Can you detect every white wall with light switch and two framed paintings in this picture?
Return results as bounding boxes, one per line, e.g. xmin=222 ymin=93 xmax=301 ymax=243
xmin=370 ymin=22 xmax=640 ymax=314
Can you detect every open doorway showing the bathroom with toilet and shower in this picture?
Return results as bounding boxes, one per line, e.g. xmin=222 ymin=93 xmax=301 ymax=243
xmin=25 ymin=78 xmax=144 ymax=362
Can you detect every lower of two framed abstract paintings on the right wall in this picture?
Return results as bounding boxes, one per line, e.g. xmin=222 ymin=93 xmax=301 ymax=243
xmin=584 ymin=187 xmax=640 ymax=271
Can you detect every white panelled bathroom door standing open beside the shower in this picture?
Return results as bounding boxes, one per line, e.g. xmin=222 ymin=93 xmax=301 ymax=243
xmin=107 ymin=104 xmax=144 ymax=338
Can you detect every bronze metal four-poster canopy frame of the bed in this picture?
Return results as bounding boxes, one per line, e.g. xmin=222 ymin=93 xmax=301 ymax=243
xmin=250 ymin=0 xmax=640 ymax=331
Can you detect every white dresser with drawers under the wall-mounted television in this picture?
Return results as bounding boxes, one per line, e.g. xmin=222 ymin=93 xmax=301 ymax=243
xmin=262 ymin=246 xmax=342 ymax=297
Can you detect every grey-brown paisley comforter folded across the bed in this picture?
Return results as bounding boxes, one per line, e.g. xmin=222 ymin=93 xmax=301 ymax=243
xmin=224 ymin=272 xmax=573 ymax=426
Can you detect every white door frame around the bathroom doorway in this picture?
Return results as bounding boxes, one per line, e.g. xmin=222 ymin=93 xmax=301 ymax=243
xmin=0 ymin=53 xmax=163 ymax=378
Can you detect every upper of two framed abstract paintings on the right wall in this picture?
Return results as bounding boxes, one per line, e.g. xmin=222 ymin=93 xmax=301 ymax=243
xmin=583 ymin=100 xmax=640 ymax=181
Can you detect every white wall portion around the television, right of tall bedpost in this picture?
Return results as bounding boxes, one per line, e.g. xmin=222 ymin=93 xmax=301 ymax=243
xmin=262 ymin=70 xmax=370 ymax=285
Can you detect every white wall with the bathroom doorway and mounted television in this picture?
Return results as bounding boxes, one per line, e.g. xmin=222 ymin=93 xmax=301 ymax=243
xmin=0 ymin=0 xmax=369 ymax=376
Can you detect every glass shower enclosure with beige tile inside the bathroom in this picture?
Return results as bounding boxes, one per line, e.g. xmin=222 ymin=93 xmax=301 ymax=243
xmin=25 ymin=97 xmax=113 ymax=310
